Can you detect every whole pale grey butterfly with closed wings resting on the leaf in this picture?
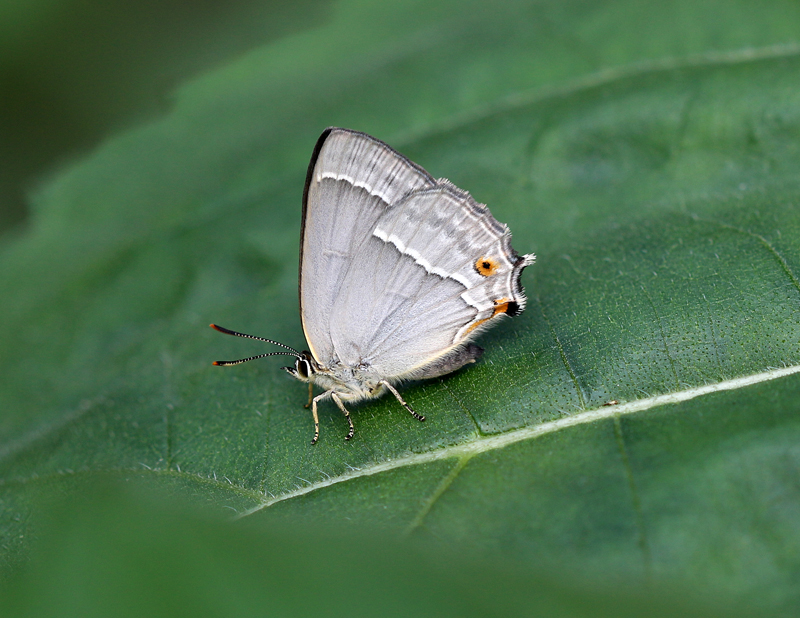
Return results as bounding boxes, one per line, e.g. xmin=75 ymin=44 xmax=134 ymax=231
xmin=211 ymin=128 xmax=535 ymax=444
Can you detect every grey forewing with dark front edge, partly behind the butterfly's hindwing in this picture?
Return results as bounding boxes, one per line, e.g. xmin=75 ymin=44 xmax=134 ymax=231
xmin=300 ymin=128 xmax=436 ymax=366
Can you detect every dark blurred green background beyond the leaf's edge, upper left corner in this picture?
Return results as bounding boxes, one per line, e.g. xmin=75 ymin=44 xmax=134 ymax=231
xmin=0 ymin=0 xmax=330 ymax=233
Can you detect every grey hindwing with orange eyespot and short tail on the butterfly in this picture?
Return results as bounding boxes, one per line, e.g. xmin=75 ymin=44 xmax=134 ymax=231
xmin=330 ymin=180 xmax=534 ymax=380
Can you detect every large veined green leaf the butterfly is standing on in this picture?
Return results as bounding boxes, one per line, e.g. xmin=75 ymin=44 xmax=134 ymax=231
xmin=0 ymin=0 xmax=800 ymax=613
